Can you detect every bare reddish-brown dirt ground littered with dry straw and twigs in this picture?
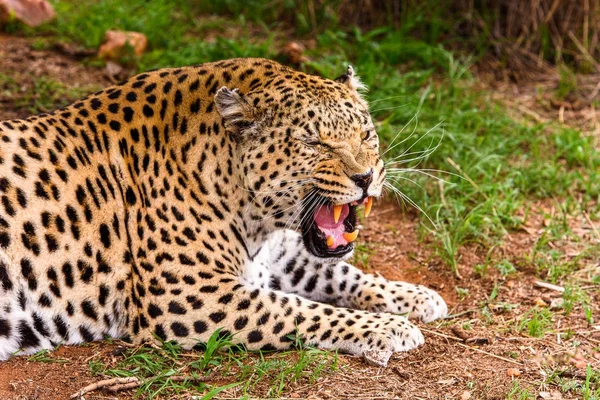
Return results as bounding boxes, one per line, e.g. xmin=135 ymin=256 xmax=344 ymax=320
xmin=0 ymin=37 xmax=600 ymax=400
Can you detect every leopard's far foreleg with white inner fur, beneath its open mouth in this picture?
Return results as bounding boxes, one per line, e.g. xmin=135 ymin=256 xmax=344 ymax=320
xmin=263 ymin=231 xmax=448 ymax=322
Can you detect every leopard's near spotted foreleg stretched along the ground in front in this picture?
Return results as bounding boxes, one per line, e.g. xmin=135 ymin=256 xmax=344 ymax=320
xmin=135 ymin=275 xmax=424 ymax=366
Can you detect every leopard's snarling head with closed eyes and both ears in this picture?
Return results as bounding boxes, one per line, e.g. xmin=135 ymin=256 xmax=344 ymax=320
xmin=215 ymin=67 xmax=385 ymax=258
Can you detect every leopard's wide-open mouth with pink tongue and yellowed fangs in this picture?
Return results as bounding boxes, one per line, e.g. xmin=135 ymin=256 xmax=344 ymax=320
xmin=302 ymin=197 xmax=373 ymax=258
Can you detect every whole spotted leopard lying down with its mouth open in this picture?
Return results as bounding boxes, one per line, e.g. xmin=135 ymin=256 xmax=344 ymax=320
xmin=0 ymin=58 xmax=448 ymax=366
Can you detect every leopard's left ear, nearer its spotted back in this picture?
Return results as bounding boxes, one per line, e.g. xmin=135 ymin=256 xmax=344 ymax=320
xmin=215 ymin=86 xmax=258 ymax=138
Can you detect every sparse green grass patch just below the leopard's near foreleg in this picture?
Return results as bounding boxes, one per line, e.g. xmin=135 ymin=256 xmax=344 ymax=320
xmin=88 ymin=330 xmax=340 ymax=400
